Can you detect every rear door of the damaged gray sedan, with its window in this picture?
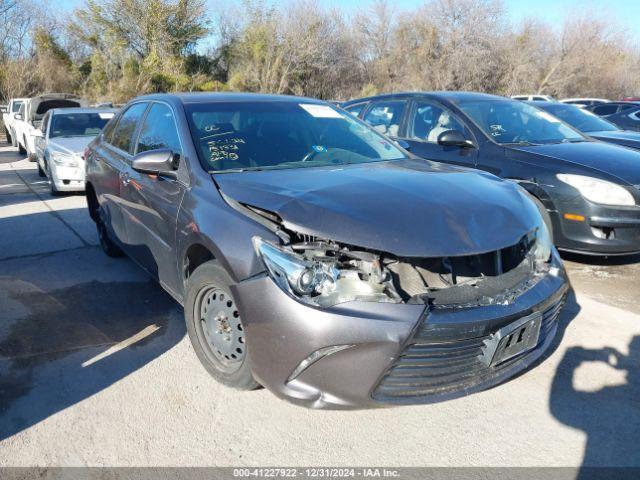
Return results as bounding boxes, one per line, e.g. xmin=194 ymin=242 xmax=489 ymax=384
xmin=91 ymin=102 xmax=148 ymax=249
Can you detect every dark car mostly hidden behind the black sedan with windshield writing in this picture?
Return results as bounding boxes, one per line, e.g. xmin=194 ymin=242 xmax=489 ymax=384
xmin=531 ymin=102 xmax=640 ymax=149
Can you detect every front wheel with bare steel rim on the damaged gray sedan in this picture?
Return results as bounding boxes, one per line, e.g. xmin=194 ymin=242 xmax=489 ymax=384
xmin=184 ymin=260 xmax=260 ymax=390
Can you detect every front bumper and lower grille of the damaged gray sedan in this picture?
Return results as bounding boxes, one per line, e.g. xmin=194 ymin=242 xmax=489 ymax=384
xmin=233 ymin=254 xmax=569 ymax=409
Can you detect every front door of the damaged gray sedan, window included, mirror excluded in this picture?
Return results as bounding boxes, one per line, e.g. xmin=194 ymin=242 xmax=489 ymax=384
xmin=122 ymin=102 xmax=188 ymax=293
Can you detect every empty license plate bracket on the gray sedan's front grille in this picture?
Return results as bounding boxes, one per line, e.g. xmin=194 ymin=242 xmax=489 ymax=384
xmin=480 ymin=312 xmax=542 ymax=367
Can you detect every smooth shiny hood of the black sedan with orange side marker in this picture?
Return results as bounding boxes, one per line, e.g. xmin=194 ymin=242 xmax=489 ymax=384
xmin=512 ymin=142 xmax=640 ymax=185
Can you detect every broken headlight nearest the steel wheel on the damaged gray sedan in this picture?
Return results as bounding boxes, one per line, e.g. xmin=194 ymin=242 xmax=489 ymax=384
xmin=253 ymin=237 xmax=401 ymax=307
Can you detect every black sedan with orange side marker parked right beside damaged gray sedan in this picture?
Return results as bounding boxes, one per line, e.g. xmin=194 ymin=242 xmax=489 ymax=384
xmin=342 ymin=92 xmax=640 ymax=255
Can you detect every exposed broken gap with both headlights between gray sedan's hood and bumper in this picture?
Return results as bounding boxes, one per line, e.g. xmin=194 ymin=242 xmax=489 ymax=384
xmin=253 ymin=224 xmax=555 ymax=308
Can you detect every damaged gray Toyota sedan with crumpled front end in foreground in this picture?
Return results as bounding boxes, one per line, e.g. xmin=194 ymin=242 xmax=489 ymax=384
xmin=85 ymin=93 xmax=569 ymax=408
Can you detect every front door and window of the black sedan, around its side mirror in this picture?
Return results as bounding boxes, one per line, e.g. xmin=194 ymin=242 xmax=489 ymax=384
xmin=402 ymin=99 xmax=478 ymax=167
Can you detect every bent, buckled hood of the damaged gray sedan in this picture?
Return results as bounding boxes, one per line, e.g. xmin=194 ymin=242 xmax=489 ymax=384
xmin=213 ymin=159 xmax=540 ymax=257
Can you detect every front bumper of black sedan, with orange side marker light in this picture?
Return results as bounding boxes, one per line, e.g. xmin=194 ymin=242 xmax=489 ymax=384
xmin=554 ymin=192 xmax=640 ymax=255
